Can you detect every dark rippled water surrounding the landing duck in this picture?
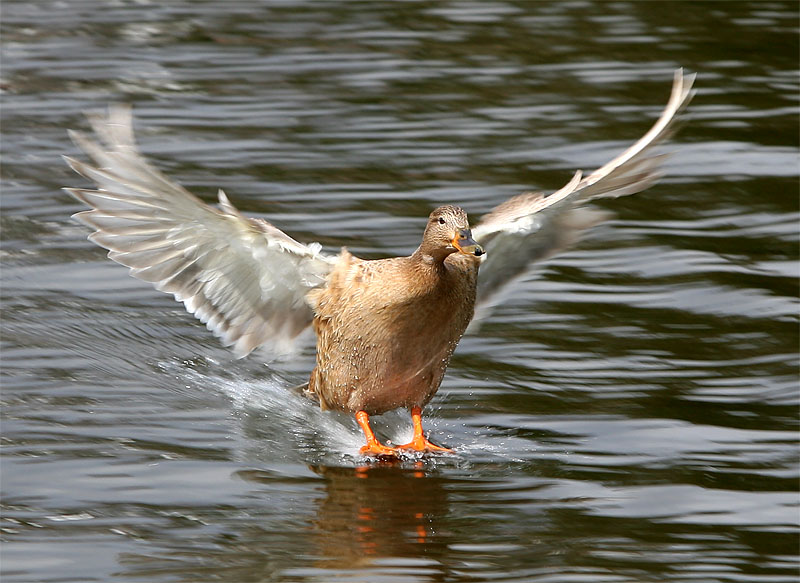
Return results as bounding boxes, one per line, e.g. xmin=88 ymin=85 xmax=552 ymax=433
xmin=0 ymin=0 xmax=800 ymax=583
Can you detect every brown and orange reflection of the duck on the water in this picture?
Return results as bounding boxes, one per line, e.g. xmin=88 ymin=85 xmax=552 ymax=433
xmin=311 ymin=462 xmax=448 ymax=568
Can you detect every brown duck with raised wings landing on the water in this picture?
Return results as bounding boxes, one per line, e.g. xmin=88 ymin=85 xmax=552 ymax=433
xmin=64 ymin=69 xmax=695 ymax=458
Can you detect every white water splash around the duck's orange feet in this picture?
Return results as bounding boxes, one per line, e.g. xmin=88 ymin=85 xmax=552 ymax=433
xmin=158 ymin=358 xmax=520 ymax=466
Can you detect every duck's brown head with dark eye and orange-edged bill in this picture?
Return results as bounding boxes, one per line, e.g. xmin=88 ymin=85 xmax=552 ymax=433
xmin=417 ymin=205 xmax=484 ymax=261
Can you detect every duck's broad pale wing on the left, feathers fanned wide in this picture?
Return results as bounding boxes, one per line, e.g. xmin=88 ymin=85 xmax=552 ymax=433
xmin=65 ymin=106 xmax=336 ymax=356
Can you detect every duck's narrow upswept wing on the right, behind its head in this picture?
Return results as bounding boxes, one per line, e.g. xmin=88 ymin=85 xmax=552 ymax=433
xmin=472 ymin=69 xmax=695 ymax=305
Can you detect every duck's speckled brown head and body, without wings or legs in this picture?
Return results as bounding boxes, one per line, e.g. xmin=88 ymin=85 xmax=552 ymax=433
xmin=309 ymin=207 xmax=480 ymax=414
